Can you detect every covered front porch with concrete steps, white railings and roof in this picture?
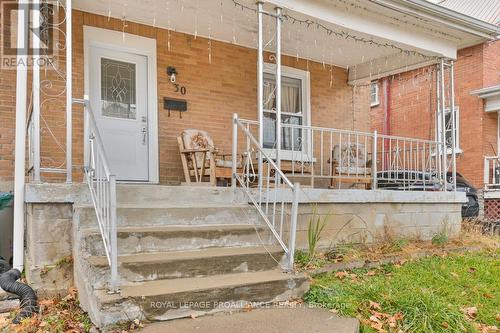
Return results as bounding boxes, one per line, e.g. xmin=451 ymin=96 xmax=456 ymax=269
xmin=8 ymin=1 xmax=480 ymax=325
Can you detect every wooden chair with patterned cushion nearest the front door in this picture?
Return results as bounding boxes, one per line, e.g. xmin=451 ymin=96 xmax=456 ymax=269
xmin=177 ymin=129 xmax=241 ymax=186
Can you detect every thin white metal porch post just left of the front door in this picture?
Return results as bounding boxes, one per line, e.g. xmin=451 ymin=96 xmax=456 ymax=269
xmin=66 ymin=0 xmax=73 ymax=183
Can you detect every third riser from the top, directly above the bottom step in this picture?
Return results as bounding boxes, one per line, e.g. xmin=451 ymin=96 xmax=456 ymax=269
xmin=90 ymin=252 xmax=283 ymax=289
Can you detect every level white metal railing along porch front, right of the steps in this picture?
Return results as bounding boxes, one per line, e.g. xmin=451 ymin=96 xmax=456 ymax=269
xmin=252 ymin=122 xmax=449 ymax=190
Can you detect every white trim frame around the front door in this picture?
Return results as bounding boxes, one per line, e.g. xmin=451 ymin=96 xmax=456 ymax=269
xmin=83 ymin=26 xmax=160 ymax=183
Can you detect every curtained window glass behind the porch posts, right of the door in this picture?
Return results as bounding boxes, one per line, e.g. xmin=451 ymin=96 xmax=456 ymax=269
xmin=264 ymin=73 xmax=304 ymax=151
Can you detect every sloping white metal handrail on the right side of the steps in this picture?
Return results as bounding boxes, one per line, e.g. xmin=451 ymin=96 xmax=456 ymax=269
xmin=232 ymin=114 xmax=300 ymax=270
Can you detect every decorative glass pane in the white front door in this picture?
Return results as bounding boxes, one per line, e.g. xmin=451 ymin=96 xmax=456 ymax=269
xmin=101 ymin=58 xmax=136 ymax=119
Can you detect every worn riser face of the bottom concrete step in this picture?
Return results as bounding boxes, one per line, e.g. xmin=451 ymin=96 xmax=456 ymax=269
xmin=97 ymin=278 xmax=309 ymax=322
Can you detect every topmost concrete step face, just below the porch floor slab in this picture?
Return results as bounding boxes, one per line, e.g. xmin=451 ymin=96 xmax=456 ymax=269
xmin=75 ymin=203 xmax=260 ymax=228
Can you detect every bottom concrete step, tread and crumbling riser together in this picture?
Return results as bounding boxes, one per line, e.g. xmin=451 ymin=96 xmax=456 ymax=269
xmin=91 ymin=270 xmax=309 ymax=326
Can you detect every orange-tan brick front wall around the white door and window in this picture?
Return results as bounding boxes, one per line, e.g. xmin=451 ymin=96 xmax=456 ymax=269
xmin=0 ymin=11 xmax=370 ymax=183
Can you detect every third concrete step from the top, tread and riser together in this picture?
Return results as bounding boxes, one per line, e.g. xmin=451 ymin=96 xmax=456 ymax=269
xmin=87 ymin=245 xmax=284 ymax=289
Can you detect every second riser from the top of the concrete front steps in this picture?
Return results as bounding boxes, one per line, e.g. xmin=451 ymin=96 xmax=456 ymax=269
xmin=83 ymin=228 xmax=272 ymax=256
